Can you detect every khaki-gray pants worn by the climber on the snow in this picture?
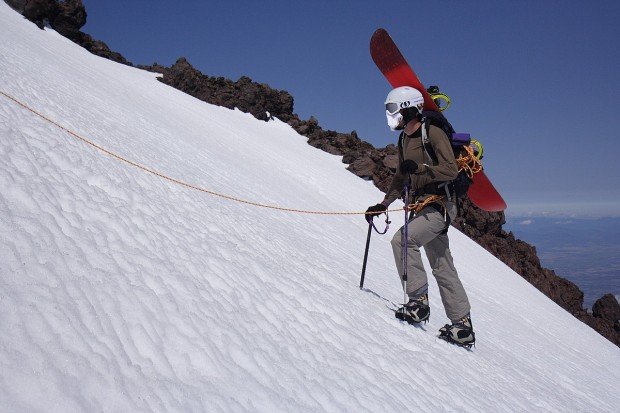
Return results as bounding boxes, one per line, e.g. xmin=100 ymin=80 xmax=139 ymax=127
xmin=392 ymin=202 xmax=470 ymax=322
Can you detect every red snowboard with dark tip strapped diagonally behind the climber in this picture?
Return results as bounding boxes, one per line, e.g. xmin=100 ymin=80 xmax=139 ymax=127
xmin=370 ymin=29 xmax=506 ymax=212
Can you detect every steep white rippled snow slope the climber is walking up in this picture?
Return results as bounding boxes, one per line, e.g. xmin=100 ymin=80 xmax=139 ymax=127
xmin=0 ymin=2 xmax=620 ymax=412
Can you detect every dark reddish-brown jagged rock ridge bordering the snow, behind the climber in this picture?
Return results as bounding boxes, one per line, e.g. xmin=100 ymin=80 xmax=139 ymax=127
xmin=5 ymin=0 xmax=620 ymax=346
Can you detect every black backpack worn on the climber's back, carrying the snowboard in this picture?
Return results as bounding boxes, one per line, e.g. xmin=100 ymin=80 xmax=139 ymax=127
xmin=422 ymin=110 xmax=473 ymax=198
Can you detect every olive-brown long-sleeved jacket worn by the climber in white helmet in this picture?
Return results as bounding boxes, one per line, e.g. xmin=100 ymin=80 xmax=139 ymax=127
xmin=383 ymin=125 xmax=458 ymax=206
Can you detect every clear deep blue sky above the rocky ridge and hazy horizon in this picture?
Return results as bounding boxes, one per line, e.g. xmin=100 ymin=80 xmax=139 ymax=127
xmin=83 ymin=0 xmax=620 ymax=216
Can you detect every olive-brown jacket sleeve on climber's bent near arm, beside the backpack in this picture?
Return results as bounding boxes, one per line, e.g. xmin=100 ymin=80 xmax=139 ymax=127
xmin=415 ymin=126 xmax=459 ymax=188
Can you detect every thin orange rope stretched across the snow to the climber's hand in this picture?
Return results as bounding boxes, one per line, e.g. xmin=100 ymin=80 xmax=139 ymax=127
xmin=0 ymin=90 xmax=402 ymax=215
